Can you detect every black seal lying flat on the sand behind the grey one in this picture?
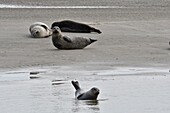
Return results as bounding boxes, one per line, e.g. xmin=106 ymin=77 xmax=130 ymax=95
xmin=51 ymin=20 xmax=102 ymax=33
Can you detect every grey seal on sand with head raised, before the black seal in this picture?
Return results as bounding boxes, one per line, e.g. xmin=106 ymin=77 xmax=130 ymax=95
xmin=52 ymin=27 xmax=97 ymax=49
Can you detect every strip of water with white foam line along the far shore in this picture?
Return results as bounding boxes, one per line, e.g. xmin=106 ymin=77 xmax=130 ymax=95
xmin=0 ymin=0 xmax=170 ymax=8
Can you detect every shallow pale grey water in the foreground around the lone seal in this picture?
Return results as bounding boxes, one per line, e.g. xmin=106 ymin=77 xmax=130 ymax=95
xmin=0 ymin=66 xmax=170 ymax=113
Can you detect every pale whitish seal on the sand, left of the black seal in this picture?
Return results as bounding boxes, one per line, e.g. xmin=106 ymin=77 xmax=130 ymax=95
xmin=29 ymin=22 xmax=52 ymax=38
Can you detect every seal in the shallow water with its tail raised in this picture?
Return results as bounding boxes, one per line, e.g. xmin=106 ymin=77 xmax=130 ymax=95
xmin=71 ymin=81 xmax=99 ymax=100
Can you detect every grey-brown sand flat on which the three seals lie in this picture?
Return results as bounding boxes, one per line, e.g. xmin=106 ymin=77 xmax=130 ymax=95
xmin=0 ymin=7 xmax=170 ymax=68
